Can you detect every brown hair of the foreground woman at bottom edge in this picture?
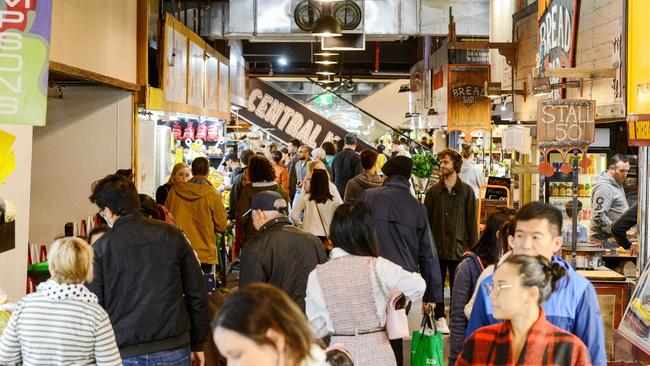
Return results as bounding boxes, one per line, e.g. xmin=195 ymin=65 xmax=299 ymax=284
xmin=212 ymin=283 xmax=313 ymax=364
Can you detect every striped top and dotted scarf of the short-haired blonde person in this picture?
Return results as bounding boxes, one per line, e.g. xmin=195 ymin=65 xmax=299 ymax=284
xmin=0 ymin=280 xmax=122 ymax=366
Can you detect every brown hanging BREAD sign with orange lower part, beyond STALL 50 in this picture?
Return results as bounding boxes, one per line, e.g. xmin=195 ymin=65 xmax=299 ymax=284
xmin=447 ymin=65 xmax=492 ymax=141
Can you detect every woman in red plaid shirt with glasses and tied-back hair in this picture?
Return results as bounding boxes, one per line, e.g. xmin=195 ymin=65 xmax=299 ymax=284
xmin=456 ymin=255 xmax=591 ymax=366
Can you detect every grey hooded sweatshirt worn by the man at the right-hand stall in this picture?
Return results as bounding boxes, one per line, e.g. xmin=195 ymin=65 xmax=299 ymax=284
xmin=589 ymin=172 xmax=630 ymax=239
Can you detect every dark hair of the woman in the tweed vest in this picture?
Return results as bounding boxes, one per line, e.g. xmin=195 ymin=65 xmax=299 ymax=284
xmin=329 ymin=200 xmax=378 ymax=257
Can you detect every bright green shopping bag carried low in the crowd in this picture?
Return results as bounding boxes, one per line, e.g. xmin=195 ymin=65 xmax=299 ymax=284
xmin=411 ymin=315 xmax=443 ymax=366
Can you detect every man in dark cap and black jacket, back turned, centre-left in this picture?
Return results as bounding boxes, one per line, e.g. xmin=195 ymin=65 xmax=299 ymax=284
xmin=239 ymin=191 xmax=327 ymax=311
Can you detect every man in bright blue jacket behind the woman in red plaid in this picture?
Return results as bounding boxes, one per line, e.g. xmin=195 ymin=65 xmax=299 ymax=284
xmin=465 ymin=202 xmax=607 ymax=366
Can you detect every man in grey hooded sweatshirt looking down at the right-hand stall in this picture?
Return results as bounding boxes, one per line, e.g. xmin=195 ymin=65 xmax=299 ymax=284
xmin=590 ymin=155 xmax=630 ymax=243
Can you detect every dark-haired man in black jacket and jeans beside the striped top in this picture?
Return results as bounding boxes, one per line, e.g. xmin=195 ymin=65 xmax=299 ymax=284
xmin=87 ymin=175 xmax=210 ymax=365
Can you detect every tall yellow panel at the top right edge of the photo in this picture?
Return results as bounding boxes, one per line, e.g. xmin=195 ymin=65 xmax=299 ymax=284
xmin=627 ymin=0 xmax=650 ymax=114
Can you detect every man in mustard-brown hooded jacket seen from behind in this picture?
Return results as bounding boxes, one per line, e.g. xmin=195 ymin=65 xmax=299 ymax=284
xmin=165 ymin=157 xmax=226 ymax=273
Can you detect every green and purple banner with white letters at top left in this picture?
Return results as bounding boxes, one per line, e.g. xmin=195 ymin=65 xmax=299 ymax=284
xmin=0 ymin=0 xmax=52 ymax=126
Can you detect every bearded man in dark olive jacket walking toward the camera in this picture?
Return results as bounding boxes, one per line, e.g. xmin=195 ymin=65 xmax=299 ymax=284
xmin=424 ymin=149 xmax=478 ymax=333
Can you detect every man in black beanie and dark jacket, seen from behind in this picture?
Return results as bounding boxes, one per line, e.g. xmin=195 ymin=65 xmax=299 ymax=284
xmin=361 ymin=155 xmax=443 ymax=366
